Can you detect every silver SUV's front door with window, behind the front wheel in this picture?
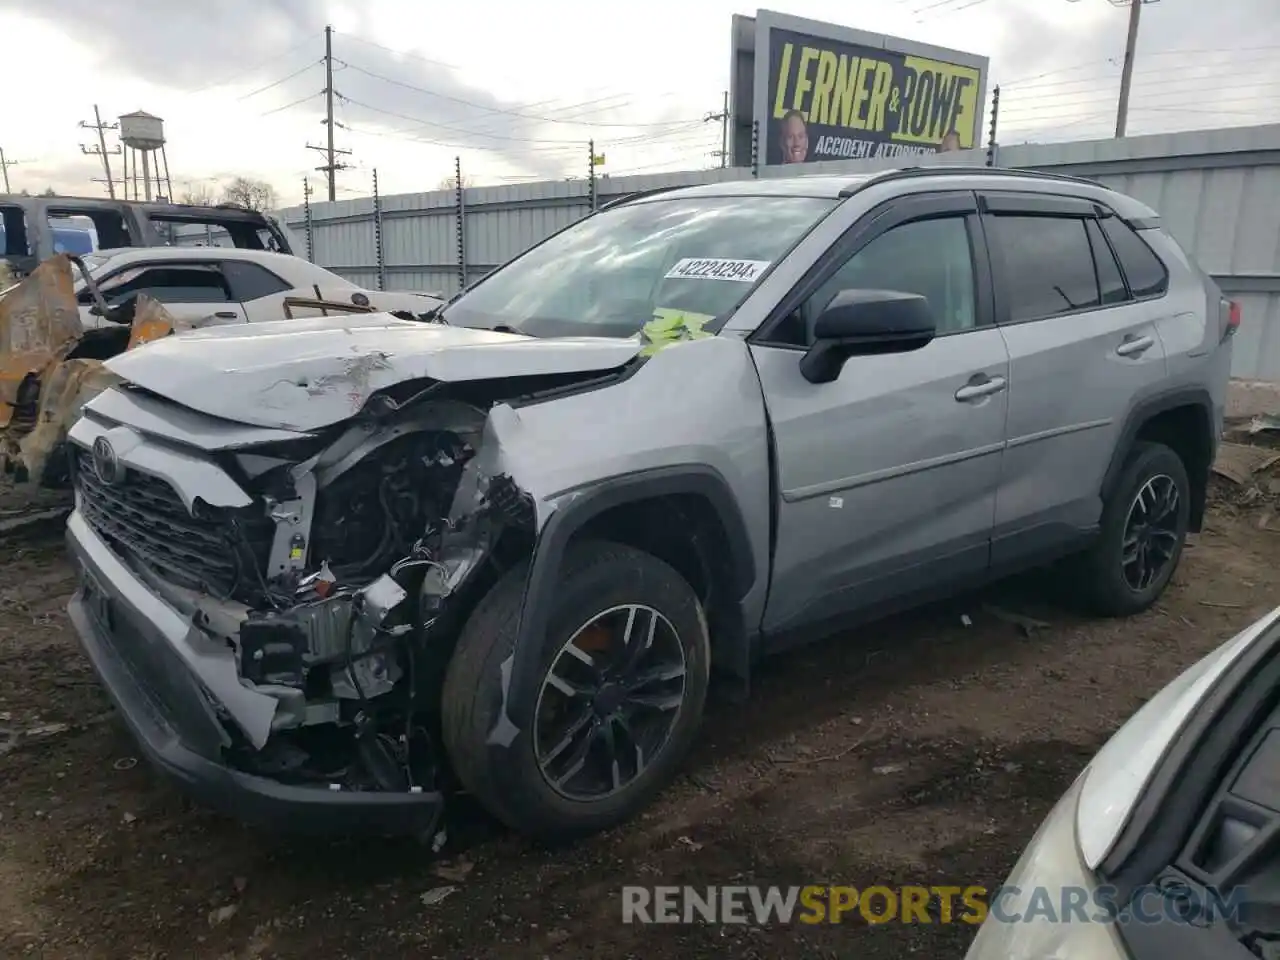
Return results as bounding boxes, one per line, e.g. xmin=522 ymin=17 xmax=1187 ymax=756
xmin=750 ymin=193 xmax=1009 ymax=634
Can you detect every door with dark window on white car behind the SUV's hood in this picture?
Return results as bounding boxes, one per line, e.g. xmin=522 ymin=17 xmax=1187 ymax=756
xmin=81 ymin=260 xmax=246 ymax=328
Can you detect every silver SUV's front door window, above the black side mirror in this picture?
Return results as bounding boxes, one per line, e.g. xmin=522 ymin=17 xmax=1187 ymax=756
xmin=801 ymin=216 xmax=977 ymax=343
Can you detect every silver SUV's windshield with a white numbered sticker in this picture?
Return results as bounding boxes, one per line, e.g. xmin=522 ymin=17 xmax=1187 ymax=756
xmin=444 ymin=196 xmax=837 ymax=337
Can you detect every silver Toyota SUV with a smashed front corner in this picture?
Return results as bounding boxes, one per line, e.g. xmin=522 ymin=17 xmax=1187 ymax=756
xmin=60 ymin=168 xmax=1239 ymax=838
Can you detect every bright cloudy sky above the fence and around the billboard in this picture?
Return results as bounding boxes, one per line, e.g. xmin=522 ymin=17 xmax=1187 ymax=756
xmin=0 ymin=0 xmax=1280 ymax=204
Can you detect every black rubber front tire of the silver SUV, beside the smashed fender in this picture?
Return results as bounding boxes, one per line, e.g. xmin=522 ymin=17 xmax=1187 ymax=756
xmin=442 ymin=540 xmax=710 ymax=842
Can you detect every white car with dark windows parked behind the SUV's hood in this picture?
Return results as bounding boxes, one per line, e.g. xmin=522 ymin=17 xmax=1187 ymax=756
xmin=76 ymin=247 xmax=443 ymax=329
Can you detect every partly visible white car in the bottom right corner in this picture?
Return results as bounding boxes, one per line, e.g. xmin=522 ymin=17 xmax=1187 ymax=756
xmin=965 ymin=607 xmax=1280 ymax=960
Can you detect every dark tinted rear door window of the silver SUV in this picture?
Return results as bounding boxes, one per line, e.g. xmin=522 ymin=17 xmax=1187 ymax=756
xmin=993 ymin=216 xmax=1101 ymax=321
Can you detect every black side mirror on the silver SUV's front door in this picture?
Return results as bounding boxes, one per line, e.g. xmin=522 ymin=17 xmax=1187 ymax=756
xmin=800 ymin=289 xmax=937 ymax=383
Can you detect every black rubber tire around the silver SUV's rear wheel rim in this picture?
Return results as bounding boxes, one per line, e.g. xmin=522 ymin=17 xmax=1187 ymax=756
xmin=1078 ymin=442 xmax=1190 ymax=617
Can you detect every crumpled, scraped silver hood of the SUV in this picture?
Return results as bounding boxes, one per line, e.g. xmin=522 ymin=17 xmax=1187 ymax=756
xmin=108 ymin=314 xmax=641 ymax=430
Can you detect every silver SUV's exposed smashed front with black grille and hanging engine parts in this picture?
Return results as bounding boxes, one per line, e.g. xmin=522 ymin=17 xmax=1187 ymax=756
xmin=73 ymin=378 xmax=556 ymax=791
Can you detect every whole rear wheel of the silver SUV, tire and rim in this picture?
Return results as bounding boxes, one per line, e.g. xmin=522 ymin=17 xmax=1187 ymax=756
xmin=1080 ymin=442 xmax=1190 ymax=616
